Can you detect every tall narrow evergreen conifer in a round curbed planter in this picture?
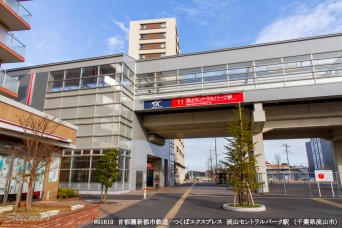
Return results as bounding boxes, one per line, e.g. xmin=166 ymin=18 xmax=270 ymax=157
xmin=222 ymin=103 xmax=262 ymax=206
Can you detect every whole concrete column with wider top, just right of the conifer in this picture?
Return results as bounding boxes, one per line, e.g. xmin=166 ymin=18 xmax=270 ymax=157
xmin=251 ymin=103 xmax=269 ymax=192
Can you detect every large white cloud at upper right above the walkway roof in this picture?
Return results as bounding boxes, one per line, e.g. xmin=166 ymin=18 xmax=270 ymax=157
xmin=255 ymin=0 xmax=342 ymax=43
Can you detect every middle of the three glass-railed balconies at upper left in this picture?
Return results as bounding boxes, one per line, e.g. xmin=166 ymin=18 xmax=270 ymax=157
xmin=0 ymin=28 xmax=26 ymax=64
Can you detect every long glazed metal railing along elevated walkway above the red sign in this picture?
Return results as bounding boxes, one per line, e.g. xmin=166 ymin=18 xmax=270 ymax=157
xmin=135 ymin=54 xmax=342 ymax=100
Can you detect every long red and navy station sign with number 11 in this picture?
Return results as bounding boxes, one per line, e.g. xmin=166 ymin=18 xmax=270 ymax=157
xmin=144 ymin=93 xmax=244 ymax=109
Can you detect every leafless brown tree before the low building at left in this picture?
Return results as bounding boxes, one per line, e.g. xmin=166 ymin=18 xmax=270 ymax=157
xmin=14 ymin=114 xmax=61 ymax=211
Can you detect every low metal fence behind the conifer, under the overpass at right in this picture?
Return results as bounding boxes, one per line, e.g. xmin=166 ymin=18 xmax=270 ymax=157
xmin=259 ymin=172 xmax=342 ymax=197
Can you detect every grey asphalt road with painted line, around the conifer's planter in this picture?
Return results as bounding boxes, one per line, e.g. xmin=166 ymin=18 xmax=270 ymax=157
xmin=89 ymin=183 xmax=342 ymax=227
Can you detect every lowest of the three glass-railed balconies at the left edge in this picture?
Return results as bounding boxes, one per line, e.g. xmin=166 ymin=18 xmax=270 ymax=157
xmin=0 ymin=69 xmax=19 ymax=98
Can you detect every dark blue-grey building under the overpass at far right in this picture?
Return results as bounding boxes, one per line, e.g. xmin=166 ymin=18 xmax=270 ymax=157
xmin=305 ymin=139 xmax=335 ymax=172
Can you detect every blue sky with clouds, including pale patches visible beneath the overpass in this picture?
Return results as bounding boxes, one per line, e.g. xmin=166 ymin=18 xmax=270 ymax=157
xmin=2 ymin=0 xmax=342 ymax=170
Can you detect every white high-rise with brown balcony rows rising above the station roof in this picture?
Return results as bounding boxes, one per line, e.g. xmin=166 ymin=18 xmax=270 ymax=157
xmin=128 ymin=18 xmax=180 ymax=59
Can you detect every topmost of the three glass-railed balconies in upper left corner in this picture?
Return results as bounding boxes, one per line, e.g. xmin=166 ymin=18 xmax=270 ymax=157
xmin=0 ymin=0 xmax=32 ymax=31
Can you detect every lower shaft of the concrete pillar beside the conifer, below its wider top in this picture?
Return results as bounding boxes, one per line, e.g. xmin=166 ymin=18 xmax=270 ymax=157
xmin=253 ymin=133 xmax=269 ymax=192
